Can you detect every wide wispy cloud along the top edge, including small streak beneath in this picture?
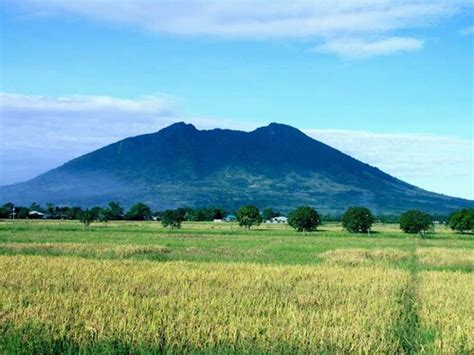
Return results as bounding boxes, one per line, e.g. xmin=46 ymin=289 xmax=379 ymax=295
xmin=9 ymin=0 xmax=472 ymax=56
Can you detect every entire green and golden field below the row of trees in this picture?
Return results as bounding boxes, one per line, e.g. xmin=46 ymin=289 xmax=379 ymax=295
xmin=0 ymin=221 xmax=474 ymax=354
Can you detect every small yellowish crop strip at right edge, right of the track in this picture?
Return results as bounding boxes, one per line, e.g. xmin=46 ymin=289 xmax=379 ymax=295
xmin=416 ymin=248 xmax=474 ymax=267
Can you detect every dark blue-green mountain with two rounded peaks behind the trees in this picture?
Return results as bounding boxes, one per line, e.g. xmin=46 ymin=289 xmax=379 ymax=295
xmin=0 ymin=122 xmax=474 ymax=214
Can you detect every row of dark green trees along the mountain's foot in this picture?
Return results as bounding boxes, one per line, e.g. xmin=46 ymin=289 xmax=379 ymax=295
xmin=0 ymin=201 xmax=474 ymax=234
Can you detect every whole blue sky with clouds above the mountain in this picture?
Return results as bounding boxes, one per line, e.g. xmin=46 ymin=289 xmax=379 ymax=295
xmin=0 ymin=0 xmax=474 ymax=199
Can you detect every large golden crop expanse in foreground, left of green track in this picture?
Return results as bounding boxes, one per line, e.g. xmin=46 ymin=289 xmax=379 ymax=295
xmin=0 ymin=256 xmax=409 ymax=353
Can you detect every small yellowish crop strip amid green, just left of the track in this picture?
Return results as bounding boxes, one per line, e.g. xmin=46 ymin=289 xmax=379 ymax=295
xmin=321 ymin=248 xmax=409 ymax=266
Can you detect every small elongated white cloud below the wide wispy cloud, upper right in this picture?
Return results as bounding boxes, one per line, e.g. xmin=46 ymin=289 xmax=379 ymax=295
xmin=315 ymin=37 xmax=423 ymax=58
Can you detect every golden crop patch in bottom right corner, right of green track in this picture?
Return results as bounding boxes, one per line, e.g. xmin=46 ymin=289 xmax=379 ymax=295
xmin=418 ymin=271 xmax=474 ymax=354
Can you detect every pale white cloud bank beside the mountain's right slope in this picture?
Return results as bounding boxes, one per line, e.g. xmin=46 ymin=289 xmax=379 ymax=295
xmin=305 ymin=129 xmax=474 ymax=199
